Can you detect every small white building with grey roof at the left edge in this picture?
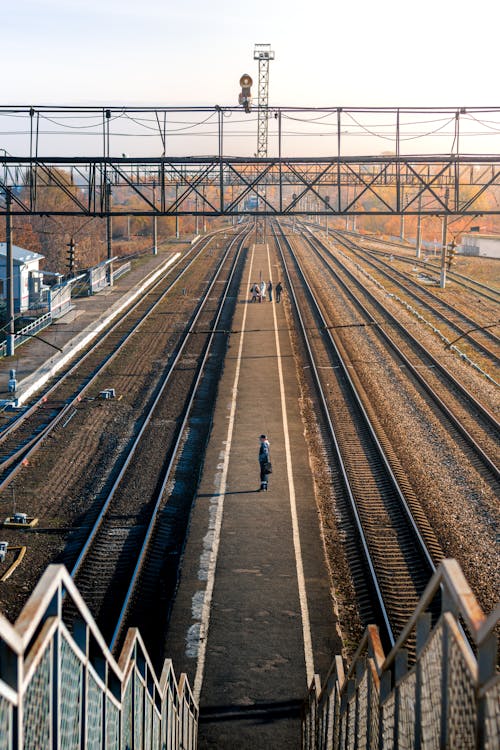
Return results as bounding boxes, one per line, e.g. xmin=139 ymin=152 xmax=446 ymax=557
xmin=0 ymin=242 xmax=44 ymax=312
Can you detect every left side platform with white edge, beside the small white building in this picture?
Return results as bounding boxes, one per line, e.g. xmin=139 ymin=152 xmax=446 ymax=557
xmin=0 ymin=248 xmax=189 ymax=404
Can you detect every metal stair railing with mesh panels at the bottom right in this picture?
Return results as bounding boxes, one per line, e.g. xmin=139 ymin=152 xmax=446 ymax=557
xmin=302 ymin=560 xmax=500 ymax=750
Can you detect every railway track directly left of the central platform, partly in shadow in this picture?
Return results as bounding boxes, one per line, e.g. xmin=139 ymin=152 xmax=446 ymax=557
xmin=66 ymin=228 xmax=250 ymax=647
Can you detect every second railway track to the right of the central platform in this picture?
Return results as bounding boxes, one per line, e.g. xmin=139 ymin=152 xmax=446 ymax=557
xmin=300 ymin=226 xmax=500 ymax=482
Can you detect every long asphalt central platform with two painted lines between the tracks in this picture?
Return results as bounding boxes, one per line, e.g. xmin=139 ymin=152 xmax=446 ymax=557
xmin=166 ymin=245 xmax=339 ymax=750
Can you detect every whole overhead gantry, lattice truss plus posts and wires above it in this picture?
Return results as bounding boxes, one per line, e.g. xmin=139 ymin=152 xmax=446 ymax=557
xmin=0 ymin=106 xmax=500 ymax=217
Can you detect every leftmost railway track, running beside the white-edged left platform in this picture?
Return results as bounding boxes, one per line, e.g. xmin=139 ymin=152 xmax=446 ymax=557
xmin=0 ymin=232 xmax=230 ymax=491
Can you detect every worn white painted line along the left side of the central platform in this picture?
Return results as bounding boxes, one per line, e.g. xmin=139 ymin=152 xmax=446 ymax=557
xmin=187 ymin=245 xmax=255 ymax=704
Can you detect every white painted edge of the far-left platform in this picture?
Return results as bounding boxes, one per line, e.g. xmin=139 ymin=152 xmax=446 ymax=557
xmin=17 ymin=253 xmax=181 ymax=406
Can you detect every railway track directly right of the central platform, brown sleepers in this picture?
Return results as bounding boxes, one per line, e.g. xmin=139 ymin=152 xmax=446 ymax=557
xmin=275 ymin=220 xmax=442 ymax=643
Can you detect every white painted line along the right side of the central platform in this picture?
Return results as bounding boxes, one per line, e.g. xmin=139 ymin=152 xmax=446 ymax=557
xmin=267 ymin=245 xmax=314 ymax=687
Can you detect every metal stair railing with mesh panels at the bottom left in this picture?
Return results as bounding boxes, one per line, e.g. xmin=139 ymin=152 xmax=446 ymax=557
xmin=0 ymin=565 xmax=198 ymax=750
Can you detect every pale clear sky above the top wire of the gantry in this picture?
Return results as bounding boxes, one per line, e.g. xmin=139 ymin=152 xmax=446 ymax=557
xmin=0 ymin=0 xmax=500 ymax=107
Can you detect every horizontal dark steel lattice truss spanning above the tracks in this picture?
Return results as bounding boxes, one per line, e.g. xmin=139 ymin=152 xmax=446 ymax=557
xmin=0 ymin=156 xmax=500 ymax=217
